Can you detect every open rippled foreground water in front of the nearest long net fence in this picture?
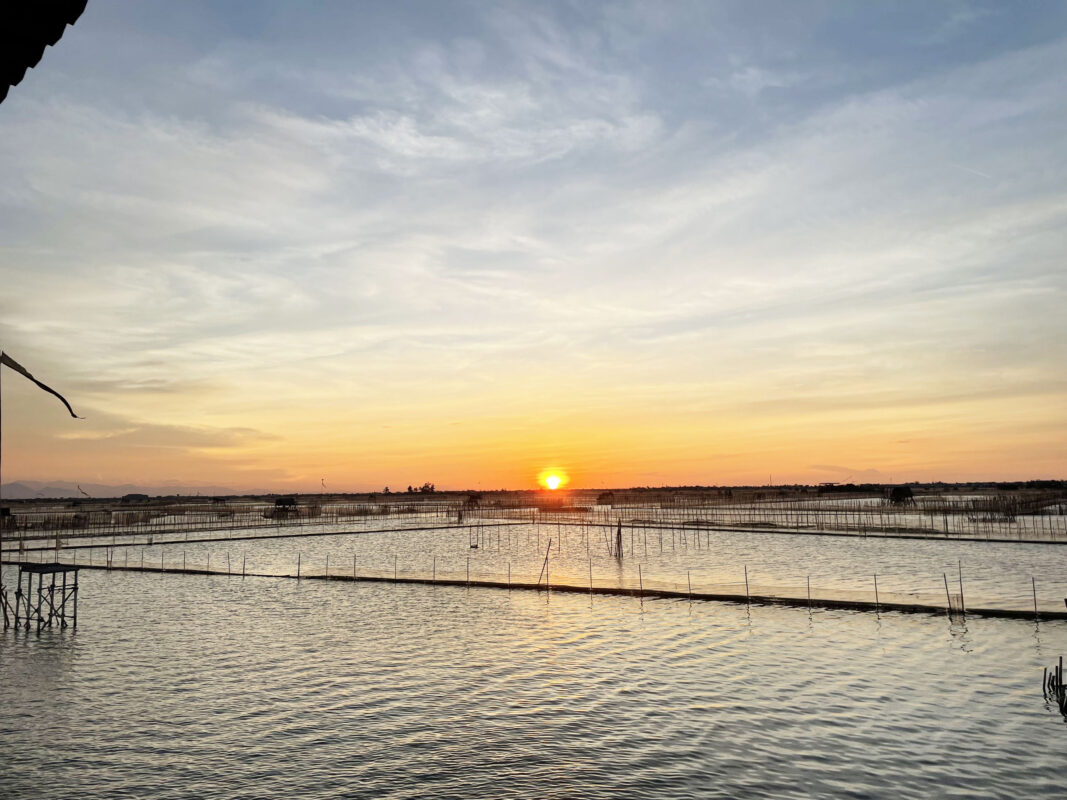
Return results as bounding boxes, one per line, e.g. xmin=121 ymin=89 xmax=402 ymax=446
xmin=0 ymin=573 xmax=1067 ymax=800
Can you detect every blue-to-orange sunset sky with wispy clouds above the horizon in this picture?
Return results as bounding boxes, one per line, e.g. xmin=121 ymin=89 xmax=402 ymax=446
xmin=0 ymin=0 xmax=1067 ymax=492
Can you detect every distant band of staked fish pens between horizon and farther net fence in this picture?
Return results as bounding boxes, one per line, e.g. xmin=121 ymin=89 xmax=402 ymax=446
xmin=2 ymin=490 xmax=1067 ymax=549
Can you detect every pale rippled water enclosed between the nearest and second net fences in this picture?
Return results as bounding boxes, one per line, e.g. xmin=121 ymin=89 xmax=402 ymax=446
xmin=60 ymin=524 xmax=1067 ymax=611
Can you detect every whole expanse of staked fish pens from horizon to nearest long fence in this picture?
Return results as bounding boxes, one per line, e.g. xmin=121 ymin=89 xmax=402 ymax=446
xmin=2 ymin=490 xmax=1067 ymax=621
